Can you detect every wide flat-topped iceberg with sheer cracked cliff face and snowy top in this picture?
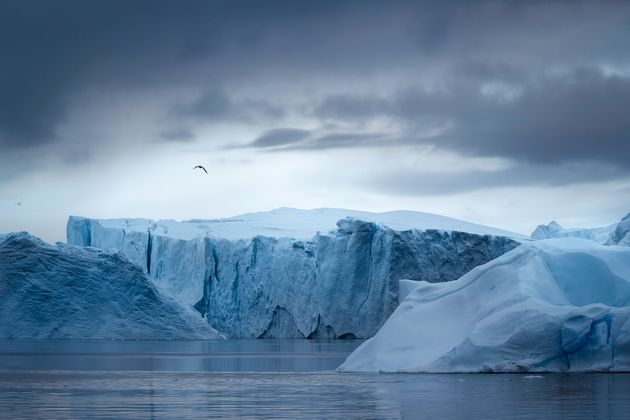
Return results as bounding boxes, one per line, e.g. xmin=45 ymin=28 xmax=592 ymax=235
xmin=68 ymin=209 xmax=519 ymax=338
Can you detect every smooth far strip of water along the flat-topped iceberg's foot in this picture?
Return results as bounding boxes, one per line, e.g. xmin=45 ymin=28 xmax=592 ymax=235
xmin=0 ymin=340 xmax=361 ymax=372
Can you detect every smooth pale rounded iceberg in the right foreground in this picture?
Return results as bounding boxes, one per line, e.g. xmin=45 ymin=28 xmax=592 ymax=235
xmin=339 ymin=239 xmax=630 ymax=372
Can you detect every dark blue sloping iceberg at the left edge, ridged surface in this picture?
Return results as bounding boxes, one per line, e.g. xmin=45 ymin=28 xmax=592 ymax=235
xmin=0 ymin=232 xmax=220 ymax=340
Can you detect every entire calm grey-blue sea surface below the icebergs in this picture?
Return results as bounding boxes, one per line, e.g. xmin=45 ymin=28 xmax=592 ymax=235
xmin=0 ymin=340 xmax=630 ymax=420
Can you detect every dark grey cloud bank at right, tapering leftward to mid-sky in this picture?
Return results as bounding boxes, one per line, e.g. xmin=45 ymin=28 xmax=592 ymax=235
xmin=316 ymin=69 xmax=630 ymax=169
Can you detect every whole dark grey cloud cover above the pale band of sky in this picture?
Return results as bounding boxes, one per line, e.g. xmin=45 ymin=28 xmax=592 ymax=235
xmin=0 ymin=0 xmax=630 ymax=194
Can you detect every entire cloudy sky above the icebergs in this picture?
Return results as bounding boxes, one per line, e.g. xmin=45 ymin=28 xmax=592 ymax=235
xmin=0 ymin=0 xmax=630 ymax=241
